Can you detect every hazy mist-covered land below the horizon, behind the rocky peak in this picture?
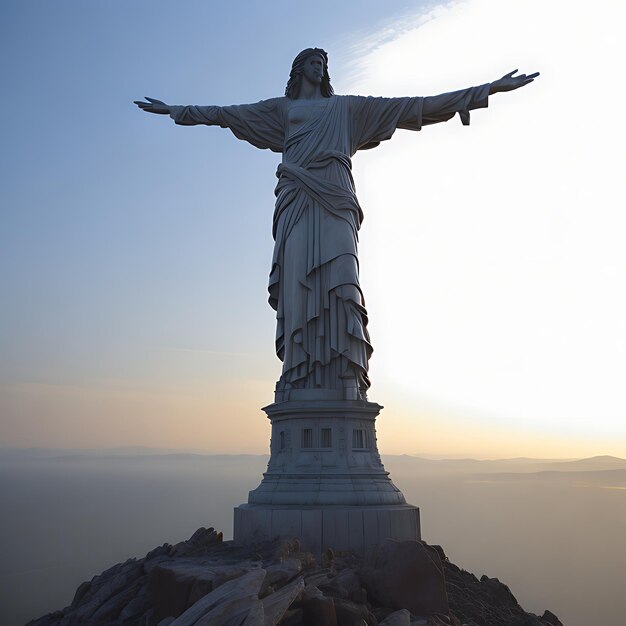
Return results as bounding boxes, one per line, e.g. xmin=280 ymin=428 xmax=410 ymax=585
xmin=0 ymin=449 xmax=626 ymax=626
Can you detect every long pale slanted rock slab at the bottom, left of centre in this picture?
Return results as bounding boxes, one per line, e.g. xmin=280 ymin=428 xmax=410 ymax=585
xmin=172 ymin=568 xmax=265 ymax=626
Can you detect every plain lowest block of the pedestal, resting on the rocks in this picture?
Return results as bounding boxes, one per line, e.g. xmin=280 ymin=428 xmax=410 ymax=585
xmin=234 ymin=504 xmax=421 ymax=555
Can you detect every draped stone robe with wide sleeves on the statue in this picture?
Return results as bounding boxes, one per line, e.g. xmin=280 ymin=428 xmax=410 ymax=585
xmin=170 ymin=85 xmax=489 ymax=399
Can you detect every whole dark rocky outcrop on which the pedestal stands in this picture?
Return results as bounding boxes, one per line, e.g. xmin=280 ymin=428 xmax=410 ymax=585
xmin=29 ymin=528 xmax=563 ymax=626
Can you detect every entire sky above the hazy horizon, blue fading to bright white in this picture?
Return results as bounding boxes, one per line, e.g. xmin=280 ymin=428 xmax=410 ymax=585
xmin=0 ymin=0 xmax=626 ymax=458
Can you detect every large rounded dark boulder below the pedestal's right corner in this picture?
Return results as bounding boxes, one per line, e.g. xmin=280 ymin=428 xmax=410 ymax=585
xmin=361 ymin=539 xmax=448 ymax=615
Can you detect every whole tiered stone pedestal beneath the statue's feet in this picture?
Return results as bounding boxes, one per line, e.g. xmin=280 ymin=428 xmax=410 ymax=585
xmin=234 ymin=398 xmax=420 ymax=553
